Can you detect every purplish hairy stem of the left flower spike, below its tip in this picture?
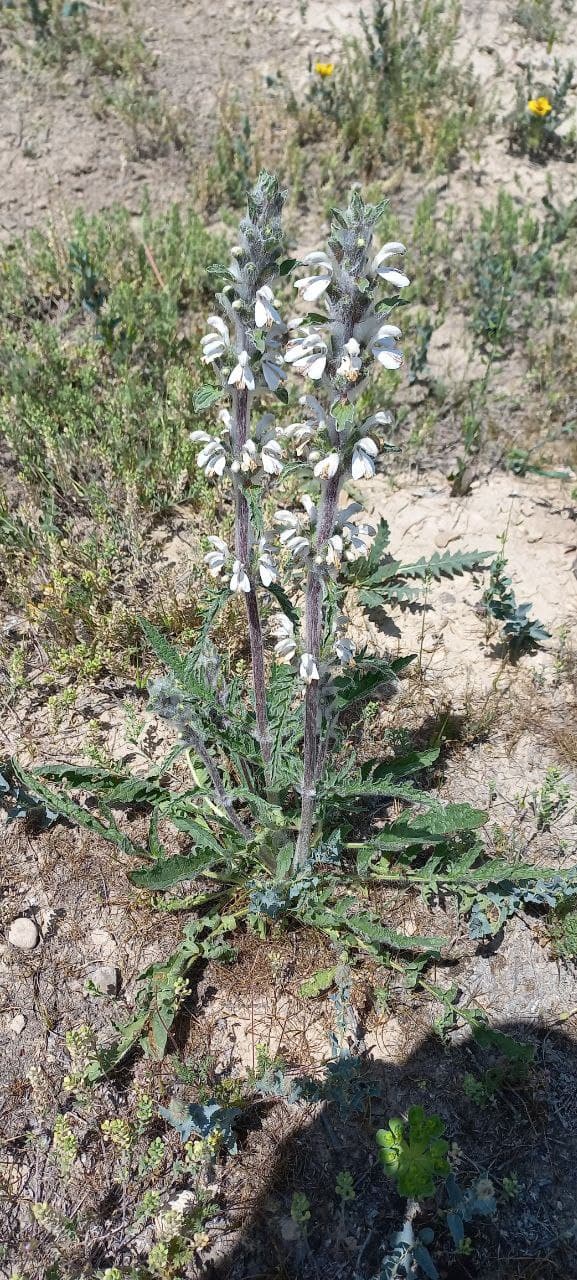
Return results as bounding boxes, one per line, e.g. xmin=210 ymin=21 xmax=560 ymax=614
xmin=232 ymin=389 xmax=273 ymax=780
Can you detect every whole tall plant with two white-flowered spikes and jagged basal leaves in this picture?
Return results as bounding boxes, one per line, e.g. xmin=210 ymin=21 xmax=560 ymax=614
xmin=12 ymin=173 xmax=486 ymax=1069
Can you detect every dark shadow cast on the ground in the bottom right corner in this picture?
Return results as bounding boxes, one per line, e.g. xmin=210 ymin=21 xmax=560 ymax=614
xmin=201 ymin=1023 xmax=577 ymax=1280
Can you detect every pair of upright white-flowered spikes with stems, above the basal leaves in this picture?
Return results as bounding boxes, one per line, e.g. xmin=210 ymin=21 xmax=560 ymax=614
xmin=192 ymin=174 xmax=409 ymax=864
